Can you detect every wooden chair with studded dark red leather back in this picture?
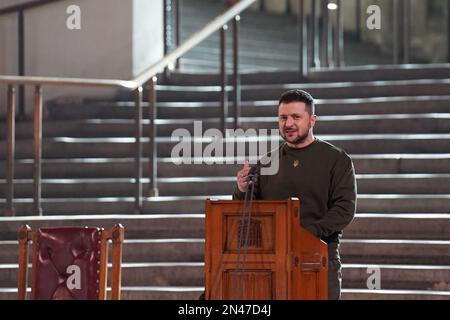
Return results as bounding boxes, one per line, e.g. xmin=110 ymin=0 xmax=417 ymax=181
xmin=17 ymin=224 xmax=124 ymax=300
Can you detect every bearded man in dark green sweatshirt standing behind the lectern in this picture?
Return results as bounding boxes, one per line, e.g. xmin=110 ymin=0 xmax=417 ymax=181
xmin=233 ymin=90 xmax=356 ymax=299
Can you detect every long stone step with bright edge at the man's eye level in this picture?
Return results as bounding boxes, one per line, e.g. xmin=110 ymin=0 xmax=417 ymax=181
xmin=4 ymin=113 xmax=450 ymax=140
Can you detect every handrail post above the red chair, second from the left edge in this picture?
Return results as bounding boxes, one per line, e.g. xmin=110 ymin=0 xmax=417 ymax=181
xmin=33 ymin=85 xmax=42 ymax=216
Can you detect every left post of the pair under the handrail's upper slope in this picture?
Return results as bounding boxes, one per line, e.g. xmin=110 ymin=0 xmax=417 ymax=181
xmin=220 ymin=25 xmax=228 ymax=134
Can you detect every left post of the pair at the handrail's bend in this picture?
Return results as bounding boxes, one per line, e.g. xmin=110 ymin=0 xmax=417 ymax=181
xmin=134 ymin=87 xmax=142 ymax=213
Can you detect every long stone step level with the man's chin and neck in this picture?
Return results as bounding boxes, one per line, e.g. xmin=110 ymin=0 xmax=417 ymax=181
xmin=0 ymin=134 xmax=450 ymax=159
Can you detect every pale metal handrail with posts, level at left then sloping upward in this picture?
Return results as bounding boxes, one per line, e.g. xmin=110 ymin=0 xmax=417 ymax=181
xmin=0 ymin=0 xmax=256 ymax=215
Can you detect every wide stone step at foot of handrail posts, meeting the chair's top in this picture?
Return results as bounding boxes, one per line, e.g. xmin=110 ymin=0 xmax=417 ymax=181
xmin=0 ymin=213 xmax=450 ymax=241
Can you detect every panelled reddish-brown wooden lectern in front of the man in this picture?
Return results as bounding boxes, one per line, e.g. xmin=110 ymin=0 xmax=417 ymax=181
xmin=205 ymin=199 xmax=328 ymax=300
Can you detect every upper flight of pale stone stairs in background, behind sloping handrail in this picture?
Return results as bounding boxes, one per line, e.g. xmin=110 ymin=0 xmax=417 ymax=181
xmin=173 ymin=0 xmax=392 ymax=73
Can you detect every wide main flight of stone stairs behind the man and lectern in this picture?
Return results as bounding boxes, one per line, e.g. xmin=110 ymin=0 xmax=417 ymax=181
xmin=0 ymin=66 xmax=450 ymax=299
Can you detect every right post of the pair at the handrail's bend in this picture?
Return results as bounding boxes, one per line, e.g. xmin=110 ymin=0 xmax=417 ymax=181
xmin=148 ymin=77 xmax=159 ymax=197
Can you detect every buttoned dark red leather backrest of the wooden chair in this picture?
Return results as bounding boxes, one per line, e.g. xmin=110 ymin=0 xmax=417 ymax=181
xmin=34 ymin=228 xmax=101 ymax=300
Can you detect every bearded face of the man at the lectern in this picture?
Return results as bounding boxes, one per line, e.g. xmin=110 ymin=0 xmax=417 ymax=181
xmin=278 ymin=102 xmax=317 ymax=145
